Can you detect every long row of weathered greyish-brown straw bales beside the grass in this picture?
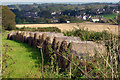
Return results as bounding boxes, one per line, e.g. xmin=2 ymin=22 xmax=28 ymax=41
xmin=7 ymin=31 xmax=106 ymax=69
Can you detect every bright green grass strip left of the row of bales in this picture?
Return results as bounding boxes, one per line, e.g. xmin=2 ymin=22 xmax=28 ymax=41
xmin=2 ymin=33 xmax=41 ymax=78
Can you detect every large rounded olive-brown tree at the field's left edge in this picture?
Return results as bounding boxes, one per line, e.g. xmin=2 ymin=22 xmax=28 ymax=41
xmin=2 ymin=6 xmax=16 ymax=30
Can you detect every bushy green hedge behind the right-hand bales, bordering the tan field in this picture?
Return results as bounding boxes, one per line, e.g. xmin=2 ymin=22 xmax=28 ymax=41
xmin=64 ymin=29 xmax=112 ymax=41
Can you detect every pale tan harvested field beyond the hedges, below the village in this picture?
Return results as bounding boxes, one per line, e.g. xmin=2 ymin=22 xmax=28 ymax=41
xmin=16 ymin=22 xmax=118 ymax=35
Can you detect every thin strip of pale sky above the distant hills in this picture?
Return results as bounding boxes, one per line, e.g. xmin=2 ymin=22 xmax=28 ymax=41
xmin=1 ymin=0 xmax=120 ymax=2
